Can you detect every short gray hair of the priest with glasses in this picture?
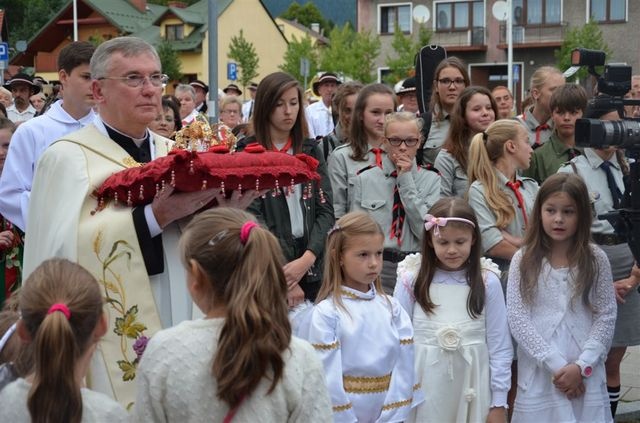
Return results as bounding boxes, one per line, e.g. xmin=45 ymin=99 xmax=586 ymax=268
xmin=89 ymin=37 xmax=160 ymax=79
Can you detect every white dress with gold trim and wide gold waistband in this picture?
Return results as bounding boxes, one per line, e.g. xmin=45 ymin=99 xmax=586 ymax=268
xmin=294 ymin=286 xmax=423 ymax=422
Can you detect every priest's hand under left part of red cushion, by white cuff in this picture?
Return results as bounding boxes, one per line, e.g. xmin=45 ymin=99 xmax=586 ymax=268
xmin=151 ymin=186 xmax=220 ymax=229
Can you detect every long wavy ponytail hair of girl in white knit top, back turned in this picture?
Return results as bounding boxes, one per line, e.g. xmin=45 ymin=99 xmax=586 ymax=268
xmin=180 ymin=208 xmax=291 ymax=408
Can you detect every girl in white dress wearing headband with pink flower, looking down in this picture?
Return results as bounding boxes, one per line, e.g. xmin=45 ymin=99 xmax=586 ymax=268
xmin=394 ymin=197 xmax=513 ymax=423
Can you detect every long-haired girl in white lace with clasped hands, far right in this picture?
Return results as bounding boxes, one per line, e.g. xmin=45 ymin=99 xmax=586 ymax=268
xmin=507 ymin=173 xmax=616 ymax=422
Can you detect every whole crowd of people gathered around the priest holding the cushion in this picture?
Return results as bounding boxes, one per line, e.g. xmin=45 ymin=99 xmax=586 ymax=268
xmin=0 ymin=37 xmax=640 ymax=423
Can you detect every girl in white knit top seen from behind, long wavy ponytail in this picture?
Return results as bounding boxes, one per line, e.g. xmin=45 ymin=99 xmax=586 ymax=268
xmin=132 ymin=208 xmax=331 ymax=423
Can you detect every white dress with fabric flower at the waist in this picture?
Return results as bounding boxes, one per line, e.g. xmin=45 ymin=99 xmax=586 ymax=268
xmin=394 ymin=254 xmax=513 ymax=423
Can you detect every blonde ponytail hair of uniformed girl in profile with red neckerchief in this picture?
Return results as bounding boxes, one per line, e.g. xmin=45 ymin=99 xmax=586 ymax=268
xmin=466 ymin=119 xmax=521 ymax=228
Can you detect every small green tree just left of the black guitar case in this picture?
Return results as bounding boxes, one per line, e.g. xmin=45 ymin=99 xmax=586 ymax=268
xmin=385 ymin=25 xmax=432 ymax=85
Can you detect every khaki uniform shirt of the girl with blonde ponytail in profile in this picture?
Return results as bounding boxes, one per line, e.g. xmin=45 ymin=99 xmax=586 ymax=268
xmin=469 ymin=170 xmax=538 ymax=254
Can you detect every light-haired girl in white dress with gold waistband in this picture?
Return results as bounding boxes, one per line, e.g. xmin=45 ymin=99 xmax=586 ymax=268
xmin=296 ymin=212 xmax=422 ymax=423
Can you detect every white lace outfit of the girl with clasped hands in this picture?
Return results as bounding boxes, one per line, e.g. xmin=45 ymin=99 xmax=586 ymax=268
xmin=507 ymin=246 xmax=616 ymax=423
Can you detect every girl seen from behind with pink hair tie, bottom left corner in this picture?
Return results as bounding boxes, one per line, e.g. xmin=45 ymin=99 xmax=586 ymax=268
xmin=0 ymin=259 xmax=129 ymax=423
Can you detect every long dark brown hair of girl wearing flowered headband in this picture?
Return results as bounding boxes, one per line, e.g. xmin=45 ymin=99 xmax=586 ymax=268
xmin=413 ymin=197 xmax=485 ymax=319
